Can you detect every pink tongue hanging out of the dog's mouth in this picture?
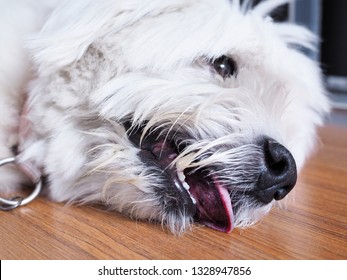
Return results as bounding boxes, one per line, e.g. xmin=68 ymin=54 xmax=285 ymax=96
xmin=186 ymin=175 xmax=234 ymax=233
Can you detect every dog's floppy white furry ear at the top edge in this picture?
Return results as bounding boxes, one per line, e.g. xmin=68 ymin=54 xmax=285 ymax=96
xmin=26 ymin=0 xmax=190 ymax=74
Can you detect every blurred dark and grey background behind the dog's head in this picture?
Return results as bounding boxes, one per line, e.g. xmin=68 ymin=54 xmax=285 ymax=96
xmin=253 ymin=0 xmax=347 ymax=126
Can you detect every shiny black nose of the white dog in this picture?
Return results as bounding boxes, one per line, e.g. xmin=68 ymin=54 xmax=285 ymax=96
xmin=254 ymin=138 xmax=297 ymax=204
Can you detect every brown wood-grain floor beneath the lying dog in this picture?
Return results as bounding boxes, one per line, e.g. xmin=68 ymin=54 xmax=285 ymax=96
xmin=0 ymin=123 xmax=347 ymax=259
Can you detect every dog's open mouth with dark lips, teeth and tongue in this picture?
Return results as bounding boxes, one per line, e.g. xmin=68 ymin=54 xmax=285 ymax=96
xmin=124 ymin=122 xmax=234 ymax=233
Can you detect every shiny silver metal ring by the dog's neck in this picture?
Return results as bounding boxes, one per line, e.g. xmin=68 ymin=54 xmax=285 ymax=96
xmin=0 ymin=157 xmax=42 ymax=210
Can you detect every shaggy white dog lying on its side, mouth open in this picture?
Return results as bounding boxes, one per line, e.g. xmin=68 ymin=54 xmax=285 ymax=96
xmin=0 ymin=0 xmax=329 ymax=233
